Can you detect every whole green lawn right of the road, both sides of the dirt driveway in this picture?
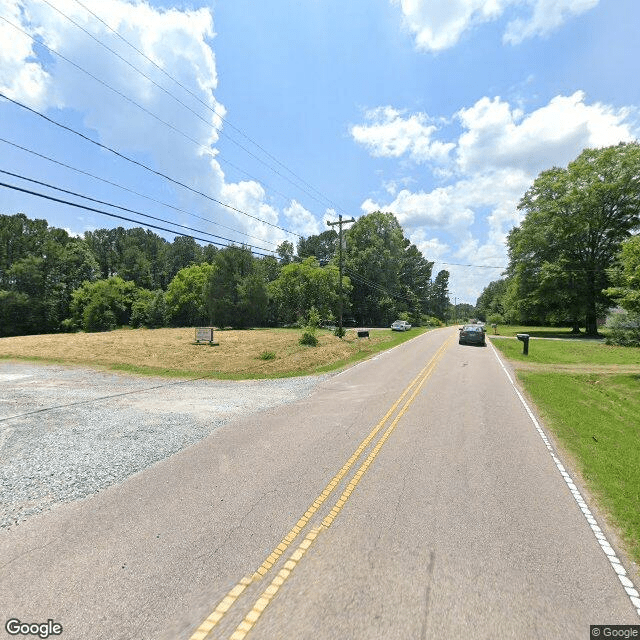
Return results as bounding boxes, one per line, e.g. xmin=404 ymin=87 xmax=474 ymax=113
xmin=496 ymin=327 xmax=640 ymax=563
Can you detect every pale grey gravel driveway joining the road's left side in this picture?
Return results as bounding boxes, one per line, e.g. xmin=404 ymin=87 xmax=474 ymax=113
xmin=0 ymin=362 xmax=328 ymax=527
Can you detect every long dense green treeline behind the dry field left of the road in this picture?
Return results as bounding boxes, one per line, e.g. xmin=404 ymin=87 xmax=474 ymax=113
xmin=0 ymin=212 xmax=450 ymax=336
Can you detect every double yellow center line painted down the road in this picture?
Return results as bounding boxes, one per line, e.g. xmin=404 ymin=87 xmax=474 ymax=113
xmin=189 ymin=336 xmax=455 ymax=640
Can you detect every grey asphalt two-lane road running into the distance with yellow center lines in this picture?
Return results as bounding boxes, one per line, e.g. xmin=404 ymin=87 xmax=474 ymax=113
xmin=0 ymin=329 xmax=640 ymax=640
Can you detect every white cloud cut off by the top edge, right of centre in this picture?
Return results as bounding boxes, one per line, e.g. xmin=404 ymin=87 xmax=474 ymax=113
xmin=391 ymin=0 xmax=599 ymax=51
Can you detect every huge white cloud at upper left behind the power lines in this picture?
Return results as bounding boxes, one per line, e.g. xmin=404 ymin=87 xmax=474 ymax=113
xmin=0 ymin=0 xmax=308 ymax=250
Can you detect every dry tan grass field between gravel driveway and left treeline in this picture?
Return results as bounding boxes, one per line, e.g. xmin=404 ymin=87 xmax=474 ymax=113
xmin=0 ymin=328 xmax=421 ymax=378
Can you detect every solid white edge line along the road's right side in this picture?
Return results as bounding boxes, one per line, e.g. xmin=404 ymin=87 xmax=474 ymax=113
xmin=489 ymin=341 xmax=640 ymax=616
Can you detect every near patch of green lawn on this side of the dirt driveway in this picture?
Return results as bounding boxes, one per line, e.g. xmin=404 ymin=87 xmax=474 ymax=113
xmin=518 ymin=371 xmax=640 ymax=562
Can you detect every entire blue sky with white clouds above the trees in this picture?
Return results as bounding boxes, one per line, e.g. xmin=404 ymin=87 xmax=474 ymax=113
xmin=0 ymin=0 xmax=640 ymax=304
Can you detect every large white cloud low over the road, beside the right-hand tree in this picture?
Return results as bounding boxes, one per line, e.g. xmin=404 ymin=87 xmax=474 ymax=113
xmin=354 ymin=91 xmax=640 ymax=302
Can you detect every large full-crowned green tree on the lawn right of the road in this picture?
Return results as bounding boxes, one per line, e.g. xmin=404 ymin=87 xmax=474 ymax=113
xmin=508 ymin=143 xmax=640 ymax=336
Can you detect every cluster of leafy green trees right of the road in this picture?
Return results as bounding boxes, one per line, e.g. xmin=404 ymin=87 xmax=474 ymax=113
xmin=476 ymin=142 xmax=640 ymax=346
